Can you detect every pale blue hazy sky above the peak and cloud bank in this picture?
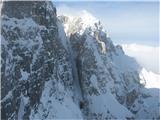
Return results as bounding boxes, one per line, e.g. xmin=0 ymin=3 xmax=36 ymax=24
xmin=54 ymin=1 xmax=159 ymax=46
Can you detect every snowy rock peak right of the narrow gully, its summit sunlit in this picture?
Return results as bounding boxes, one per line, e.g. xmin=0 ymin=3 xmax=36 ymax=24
xmin=59 ymin=12 xmax=159 ymax=119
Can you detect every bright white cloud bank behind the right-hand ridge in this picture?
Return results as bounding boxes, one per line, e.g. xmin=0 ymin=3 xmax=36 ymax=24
xmin=122 ymin=44 xmax=160 ymax=74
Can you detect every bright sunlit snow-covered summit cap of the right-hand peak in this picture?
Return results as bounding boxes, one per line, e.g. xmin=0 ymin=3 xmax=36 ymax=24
xmin=59 ymin=10 xmax=105 ymax=35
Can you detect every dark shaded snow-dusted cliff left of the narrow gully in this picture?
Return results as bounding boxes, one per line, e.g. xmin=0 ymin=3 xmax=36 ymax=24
xmin=1 ymin=1 xmax=81 ymax=119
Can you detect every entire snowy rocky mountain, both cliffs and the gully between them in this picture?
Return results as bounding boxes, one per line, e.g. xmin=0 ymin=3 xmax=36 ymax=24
xmin=1 ymin=1 xmax=160 ymax=120
